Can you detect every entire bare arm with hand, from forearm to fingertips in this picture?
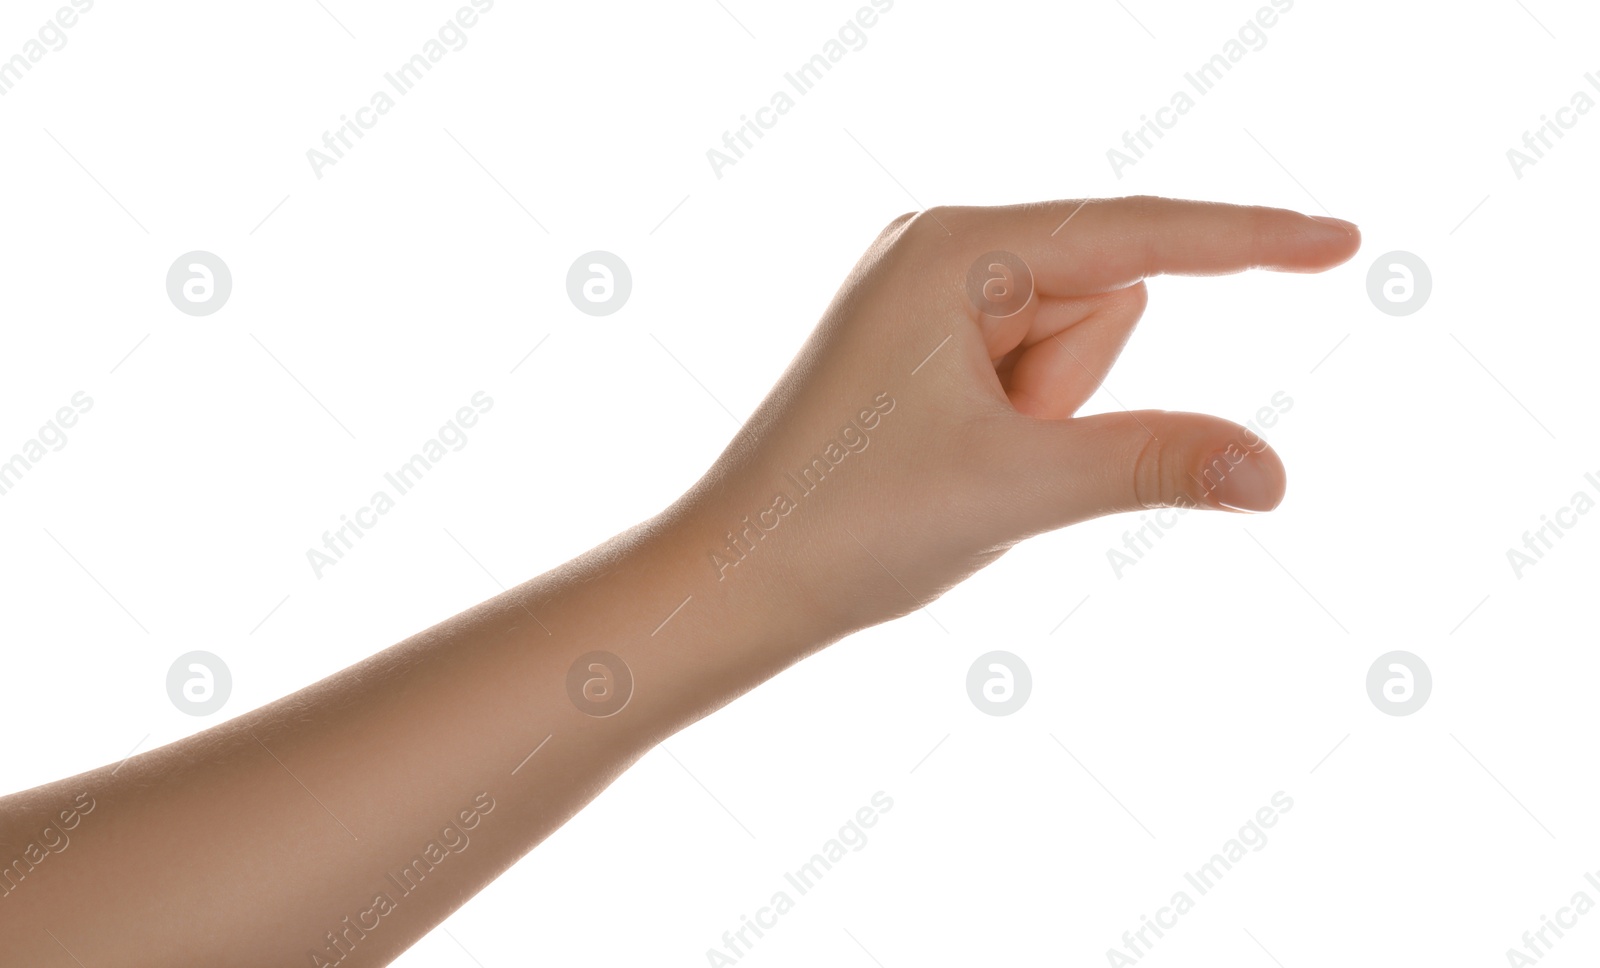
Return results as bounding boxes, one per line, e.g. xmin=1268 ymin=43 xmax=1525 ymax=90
xmin=0 ymin=197 xmax=1360 ymax=968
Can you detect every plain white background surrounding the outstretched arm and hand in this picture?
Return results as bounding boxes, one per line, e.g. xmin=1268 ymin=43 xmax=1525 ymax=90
xmin=0 ymin=0 xmax=1600 ymax=968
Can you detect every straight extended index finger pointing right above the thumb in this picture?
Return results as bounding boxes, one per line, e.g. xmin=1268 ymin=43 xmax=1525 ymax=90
xmin=941 ymin=195 xmax=1362 ymax=296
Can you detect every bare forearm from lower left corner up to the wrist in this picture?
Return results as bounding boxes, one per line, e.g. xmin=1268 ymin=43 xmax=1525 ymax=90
xmin=0 ymin=514 xmax=829 ymax=966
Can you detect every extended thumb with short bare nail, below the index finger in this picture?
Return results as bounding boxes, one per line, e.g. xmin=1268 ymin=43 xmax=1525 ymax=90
xmin=1019 ymin=410 xmax=1286 ymax=533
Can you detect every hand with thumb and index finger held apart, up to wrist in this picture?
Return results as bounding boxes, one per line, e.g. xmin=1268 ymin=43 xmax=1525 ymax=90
xmin=675 ymin=197 xmax=1360 ymax=638
